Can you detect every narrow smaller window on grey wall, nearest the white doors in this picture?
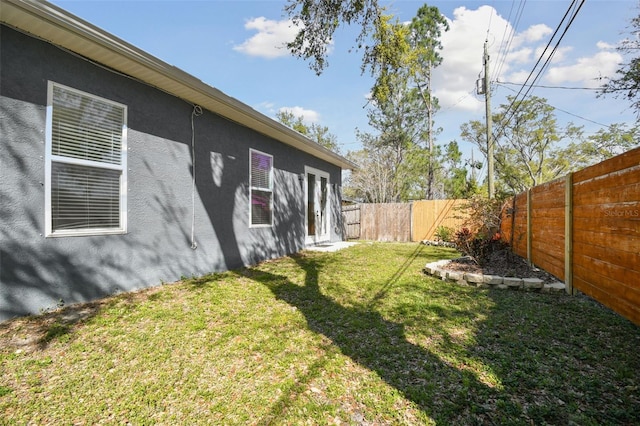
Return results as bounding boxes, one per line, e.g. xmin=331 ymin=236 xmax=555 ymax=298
xmin=249 ymin=149 xmax=273 ymax=226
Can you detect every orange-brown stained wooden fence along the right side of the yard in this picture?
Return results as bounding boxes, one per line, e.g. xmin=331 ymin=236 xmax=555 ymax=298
xmin=502 ymin=148 xmax=640 ymax=325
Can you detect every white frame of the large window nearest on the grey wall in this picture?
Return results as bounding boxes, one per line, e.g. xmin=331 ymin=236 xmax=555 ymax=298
xmin=45 ymin=81 xmax=128 ymax=237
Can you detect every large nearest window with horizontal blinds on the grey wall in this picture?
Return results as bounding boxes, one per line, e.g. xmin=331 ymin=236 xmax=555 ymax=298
xmin=45 ymin=82 xmax=127 ymax=237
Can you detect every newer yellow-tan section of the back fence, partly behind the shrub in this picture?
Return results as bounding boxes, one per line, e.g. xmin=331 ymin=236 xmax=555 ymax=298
xmin=412 ymin=200 xmax=469 ymax=241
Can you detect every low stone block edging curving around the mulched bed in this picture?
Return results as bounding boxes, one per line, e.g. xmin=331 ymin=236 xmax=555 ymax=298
xmin=423 ymin=260 xmax=565 ymax=293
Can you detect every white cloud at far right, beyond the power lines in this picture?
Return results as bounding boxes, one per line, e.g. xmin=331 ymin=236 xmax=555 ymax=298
xmin=545 ymin=50 xmax=623 ymax=88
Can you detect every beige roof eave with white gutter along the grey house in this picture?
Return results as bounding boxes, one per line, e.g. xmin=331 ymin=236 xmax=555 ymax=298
xmin=0 ymin=0 xmax=357 ymax=169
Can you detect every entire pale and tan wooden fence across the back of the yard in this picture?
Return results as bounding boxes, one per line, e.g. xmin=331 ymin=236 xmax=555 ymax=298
xmin=342 ymin=200 xmax=468 ymax=242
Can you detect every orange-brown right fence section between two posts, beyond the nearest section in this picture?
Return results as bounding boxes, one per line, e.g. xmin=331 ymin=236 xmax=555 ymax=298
xmin=530 ymin=178 xmax=565 ymax=280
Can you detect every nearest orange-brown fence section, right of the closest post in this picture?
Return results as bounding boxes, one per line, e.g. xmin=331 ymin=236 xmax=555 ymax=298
xmin=572 ymin=148 xmax=640 ymax=324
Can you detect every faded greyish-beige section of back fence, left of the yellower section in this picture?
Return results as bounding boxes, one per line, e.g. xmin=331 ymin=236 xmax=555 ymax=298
xmin=360 ymin=203 xmax=411 ymax=242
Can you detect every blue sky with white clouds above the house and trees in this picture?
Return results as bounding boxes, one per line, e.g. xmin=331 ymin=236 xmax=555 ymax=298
xmin=53 ymin=0 xmax=640 ymax=173
